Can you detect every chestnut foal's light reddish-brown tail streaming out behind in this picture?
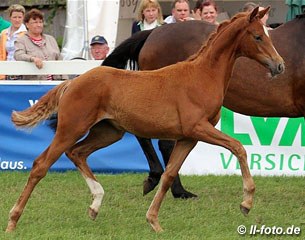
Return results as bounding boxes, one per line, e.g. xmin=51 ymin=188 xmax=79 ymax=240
xmin=12 ymin=80 xmax=71 ymax=128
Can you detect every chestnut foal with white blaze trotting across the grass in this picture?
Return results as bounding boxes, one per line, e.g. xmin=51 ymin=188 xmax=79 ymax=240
xmin=6 ymin=7 xmax=284 ymax=232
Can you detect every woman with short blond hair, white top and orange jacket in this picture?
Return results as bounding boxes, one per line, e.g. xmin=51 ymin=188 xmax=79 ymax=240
xmin=0 ymin=4 xmax=26 ymax=80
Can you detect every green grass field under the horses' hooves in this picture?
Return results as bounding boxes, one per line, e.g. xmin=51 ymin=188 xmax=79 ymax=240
xmin=0 ymin=172 xmax=305 ymax=240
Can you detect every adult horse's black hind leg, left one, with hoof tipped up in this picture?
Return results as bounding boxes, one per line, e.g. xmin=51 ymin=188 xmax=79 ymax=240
xmin=136 ymin=136 xmax=163 ymax=195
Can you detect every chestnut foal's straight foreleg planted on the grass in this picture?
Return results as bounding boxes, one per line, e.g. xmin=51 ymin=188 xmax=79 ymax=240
xmin=146 ymin=140 xmax=197 ymax=232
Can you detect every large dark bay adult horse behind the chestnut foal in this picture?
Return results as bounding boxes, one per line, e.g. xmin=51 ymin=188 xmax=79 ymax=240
xmin=103 ymin=14 xmax=305 ymax=198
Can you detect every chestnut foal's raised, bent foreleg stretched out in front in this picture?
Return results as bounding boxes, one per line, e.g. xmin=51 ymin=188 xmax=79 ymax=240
xmin=191 ymin=122 xmax=255 ymax=215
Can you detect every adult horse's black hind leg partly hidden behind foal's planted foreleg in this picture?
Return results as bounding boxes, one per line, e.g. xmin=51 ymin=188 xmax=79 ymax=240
xmin=158 ymin=140 xmax=197 ymax=199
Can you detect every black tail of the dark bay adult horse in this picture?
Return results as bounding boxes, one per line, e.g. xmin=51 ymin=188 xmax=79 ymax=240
xmin=102 ymin=30 xmax=153 ymax=70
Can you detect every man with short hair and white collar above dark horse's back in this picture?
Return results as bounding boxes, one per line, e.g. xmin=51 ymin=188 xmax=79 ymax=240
xmin=164 ymin=0 xmax=193 ymax=23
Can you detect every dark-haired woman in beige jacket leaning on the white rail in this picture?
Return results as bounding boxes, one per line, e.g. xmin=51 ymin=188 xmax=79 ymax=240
xmin=14 ymin=9 xmax=66 ymax=80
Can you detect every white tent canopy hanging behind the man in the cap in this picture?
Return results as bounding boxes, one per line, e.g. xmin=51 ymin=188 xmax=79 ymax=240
xmin=62 ymin=0 xmax=120 ymax=60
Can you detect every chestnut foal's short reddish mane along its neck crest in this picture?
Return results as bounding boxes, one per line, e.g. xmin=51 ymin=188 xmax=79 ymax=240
xmin=186 ymin=12 xmax=248 ymax=62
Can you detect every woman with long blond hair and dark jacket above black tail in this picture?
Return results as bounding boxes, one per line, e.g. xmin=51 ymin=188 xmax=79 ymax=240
xmin=131 ymin=0 xmax=163 ymax=34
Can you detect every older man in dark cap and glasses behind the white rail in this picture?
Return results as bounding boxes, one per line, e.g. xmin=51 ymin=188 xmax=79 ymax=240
xmin=90 ymin=35 xmax=109 ymax=60
